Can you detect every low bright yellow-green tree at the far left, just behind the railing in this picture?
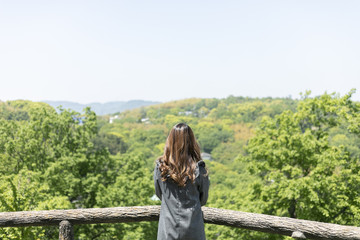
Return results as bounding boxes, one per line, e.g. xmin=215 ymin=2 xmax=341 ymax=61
xmin=0 ymin=169 xmax=72 ymax=240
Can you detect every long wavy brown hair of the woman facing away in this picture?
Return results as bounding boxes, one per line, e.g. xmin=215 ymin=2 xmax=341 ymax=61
xmin=159 ymin=123 xmax=201 ymax=187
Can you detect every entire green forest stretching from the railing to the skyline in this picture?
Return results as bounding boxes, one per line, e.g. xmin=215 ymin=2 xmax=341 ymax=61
xmin=0 ymin=90 xmax=360 ymax=240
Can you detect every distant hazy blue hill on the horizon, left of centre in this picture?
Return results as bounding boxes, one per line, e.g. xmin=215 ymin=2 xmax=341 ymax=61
xmin=42 ymin=100 xmax=160 ymax=115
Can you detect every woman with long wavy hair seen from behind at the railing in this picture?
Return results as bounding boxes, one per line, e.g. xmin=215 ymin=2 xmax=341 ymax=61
xmin=154 ymin=123 xmax=209 ymax=240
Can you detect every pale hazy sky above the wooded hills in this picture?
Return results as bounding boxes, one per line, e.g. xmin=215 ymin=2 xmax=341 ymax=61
xmin=0 ymin=0 xmax=360 ymax=103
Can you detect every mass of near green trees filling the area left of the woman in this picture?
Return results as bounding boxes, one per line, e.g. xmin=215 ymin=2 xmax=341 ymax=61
xmin=0 ymin=104 xmax=157 ymax=239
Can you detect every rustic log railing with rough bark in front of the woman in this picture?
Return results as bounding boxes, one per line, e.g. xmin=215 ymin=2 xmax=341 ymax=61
xmin=0 ymin=206 xmax=360 ymax=240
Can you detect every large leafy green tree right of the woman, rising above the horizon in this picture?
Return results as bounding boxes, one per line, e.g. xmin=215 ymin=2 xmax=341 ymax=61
xmin=247 ymin=92 xmax=360 ymax=230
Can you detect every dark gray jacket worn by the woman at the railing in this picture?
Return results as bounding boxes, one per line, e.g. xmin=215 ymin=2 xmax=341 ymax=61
xmin=154 ymin=161 xmax=209 ymax=240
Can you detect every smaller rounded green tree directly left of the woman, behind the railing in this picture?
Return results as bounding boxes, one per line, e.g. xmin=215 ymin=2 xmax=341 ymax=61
xmin=76 ymin=154 xmax=157 ymax=240
